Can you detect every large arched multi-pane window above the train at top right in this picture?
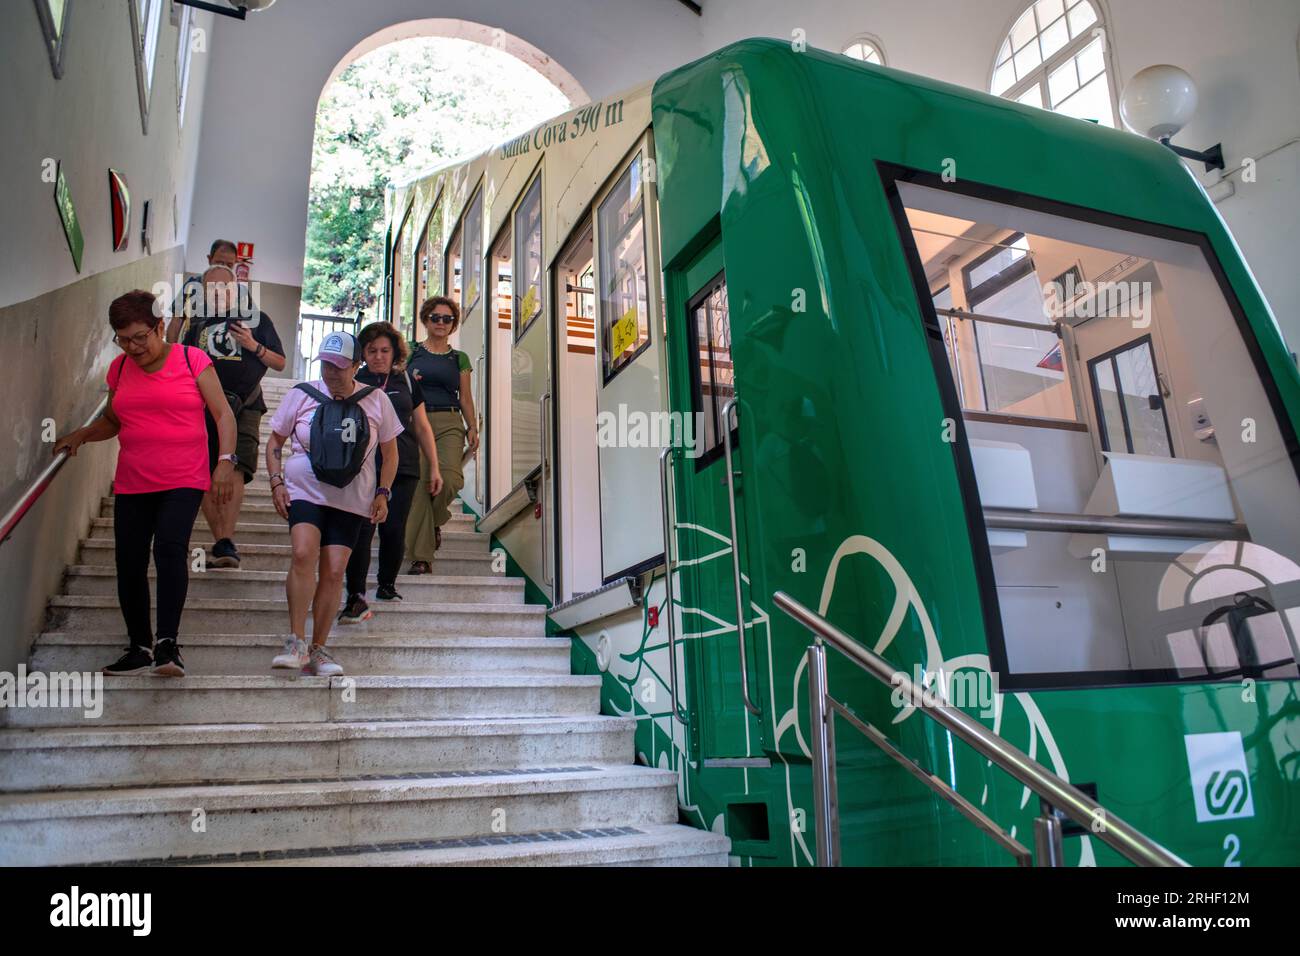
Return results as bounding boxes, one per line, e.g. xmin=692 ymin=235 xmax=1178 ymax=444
xmin=989 ymin=0 xmax=1115 ymax=126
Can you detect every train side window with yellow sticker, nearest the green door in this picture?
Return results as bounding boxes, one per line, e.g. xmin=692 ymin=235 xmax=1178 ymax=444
xmin=599 ymin=153 xmax=650 ymax=381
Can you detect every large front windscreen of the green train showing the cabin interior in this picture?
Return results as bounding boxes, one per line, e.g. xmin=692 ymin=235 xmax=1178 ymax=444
xmin=894 ymin=174 xmax=1300 ymax=689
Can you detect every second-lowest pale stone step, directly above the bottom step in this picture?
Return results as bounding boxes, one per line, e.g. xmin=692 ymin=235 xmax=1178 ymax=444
xmin=0 ymin=766 xmax=677 ymax=866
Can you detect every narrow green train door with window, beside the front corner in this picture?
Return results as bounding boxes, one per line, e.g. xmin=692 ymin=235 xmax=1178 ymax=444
xmin=666 ymin=239 xmax=767 ymax=767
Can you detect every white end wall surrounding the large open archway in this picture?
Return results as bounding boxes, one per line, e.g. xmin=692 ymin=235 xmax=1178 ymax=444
xmin=190 ymin=0 xmax=703 ymax=286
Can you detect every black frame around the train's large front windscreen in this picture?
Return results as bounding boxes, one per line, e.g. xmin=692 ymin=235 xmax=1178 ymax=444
xmin=875 ymin=160 xmax=1300 ymax=691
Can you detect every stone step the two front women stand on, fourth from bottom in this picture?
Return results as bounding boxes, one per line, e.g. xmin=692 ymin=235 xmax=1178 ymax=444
xmin=0 ymin=659 xmax=601 ymax=728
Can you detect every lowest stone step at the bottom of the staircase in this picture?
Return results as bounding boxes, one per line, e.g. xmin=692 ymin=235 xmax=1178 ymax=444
xmin=205 ymin=823 xmax=731 ymax=866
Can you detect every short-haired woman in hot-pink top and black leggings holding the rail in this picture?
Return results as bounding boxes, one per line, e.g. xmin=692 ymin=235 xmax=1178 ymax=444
xmin=55 ymin=289 xmax=235 ymax=678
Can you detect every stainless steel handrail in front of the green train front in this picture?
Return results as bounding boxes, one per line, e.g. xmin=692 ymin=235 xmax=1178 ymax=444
xmin=772 ymin=591 xmax=1187 ymax=866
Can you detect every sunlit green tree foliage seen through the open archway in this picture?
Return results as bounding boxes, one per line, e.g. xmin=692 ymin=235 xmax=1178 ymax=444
xmin=303 ymin=38 xmax=569 ymax=316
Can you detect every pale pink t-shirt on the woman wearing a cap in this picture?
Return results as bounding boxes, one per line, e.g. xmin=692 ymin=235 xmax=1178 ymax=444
xmin=270 ymin=380 xmax=403 ymax=515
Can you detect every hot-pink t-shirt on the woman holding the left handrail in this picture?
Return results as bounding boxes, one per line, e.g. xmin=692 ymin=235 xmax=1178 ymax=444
xmin=107 ymin=345 xmax=212 ymax=494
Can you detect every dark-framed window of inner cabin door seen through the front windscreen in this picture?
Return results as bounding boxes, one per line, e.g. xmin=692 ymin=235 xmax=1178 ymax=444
xmin=1088 ymin=336 xmax=1174 ymax=458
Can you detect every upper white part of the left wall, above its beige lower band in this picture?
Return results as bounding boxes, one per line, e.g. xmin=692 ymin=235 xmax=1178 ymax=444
xmin=0 ymin=0 xmax=213 ymax=307
